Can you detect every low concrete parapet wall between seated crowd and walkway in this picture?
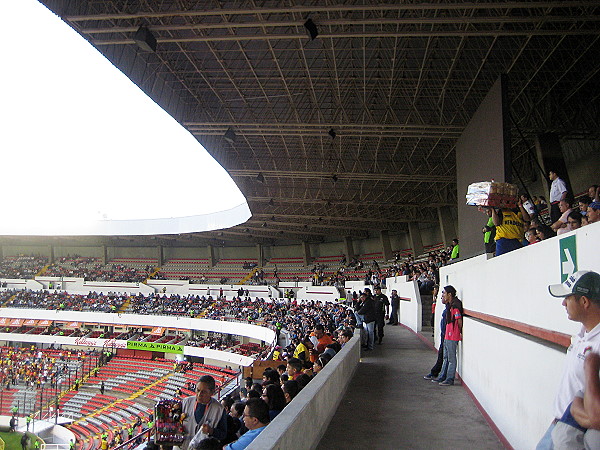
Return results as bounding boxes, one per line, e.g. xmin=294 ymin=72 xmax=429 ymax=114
xmin=246 ymin=333 xmax=360 ymax=450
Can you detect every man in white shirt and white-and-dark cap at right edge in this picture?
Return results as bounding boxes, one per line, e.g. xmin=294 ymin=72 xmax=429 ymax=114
xmin=537 ymin=270 xmax=600 ymax=450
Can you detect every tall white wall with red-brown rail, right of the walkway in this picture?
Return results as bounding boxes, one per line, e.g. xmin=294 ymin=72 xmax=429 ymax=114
xmin=436 ymin=224 xmax=600 ymax=449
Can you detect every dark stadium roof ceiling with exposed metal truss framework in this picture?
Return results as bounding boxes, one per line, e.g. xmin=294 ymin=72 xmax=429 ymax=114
xmin=20 ymin=0 xmax=600 ymax=248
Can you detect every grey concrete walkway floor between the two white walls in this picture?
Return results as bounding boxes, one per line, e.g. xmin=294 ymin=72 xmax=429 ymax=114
xmin=317 ymin=325 xmax=503 ymax=450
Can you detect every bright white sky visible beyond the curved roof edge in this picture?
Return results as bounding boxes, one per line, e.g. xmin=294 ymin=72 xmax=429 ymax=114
xmin=0 ymin=0 xmax=250 ymax=235
